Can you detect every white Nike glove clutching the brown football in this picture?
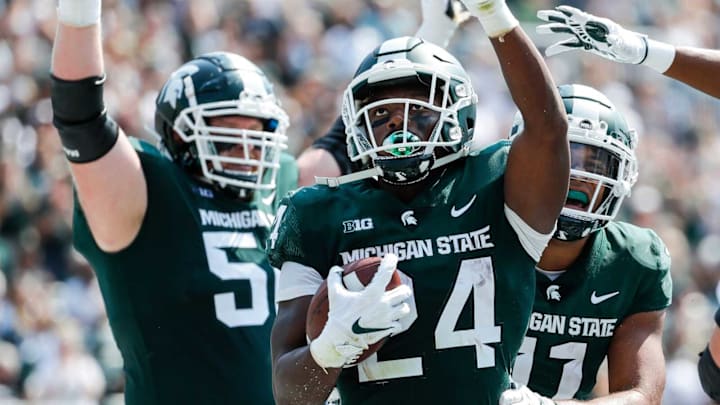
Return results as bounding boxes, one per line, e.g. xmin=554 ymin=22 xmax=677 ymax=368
xmin=310 ymin=253 xmax=412 ymax=368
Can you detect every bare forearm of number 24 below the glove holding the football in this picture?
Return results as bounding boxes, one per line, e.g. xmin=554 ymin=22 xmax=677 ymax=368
xmin=273 ymin=346 xmax=342 ymax=405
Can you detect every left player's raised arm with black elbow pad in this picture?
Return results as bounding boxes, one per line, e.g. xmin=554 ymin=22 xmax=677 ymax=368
xmin=52 ymin=0 xmax=147 ymax=252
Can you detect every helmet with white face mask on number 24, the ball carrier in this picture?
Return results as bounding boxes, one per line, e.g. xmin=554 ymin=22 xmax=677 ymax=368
xmin=342 ymin=37 xmax=477 ymax=185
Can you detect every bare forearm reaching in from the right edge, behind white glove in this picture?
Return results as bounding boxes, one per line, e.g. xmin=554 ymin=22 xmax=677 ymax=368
xmin=664 ymin=47 xmax=720 ymax=98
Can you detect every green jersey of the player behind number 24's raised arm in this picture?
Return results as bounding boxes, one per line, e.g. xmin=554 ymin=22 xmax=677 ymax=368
xmin=513 ymin=222 xmax=672 ymax=399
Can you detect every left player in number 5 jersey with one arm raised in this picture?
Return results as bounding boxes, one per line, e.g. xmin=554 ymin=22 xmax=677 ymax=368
xmin=52 ymin=0 xmax=297 ymax=404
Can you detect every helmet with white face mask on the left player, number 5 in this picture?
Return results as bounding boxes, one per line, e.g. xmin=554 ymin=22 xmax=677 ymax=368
xmin=155 ymin=52 xmax=289 ymax=196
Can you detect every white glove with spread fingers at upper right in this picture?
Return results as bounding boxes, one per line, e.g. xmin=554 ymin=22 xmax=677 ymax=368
xmin=537 ymin=6 xmax=675 ymax=73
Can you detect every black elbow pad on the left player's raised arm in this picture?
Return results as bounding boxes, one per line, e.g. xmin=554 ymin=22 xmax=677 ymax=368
xmin=51 ymin=75 xmax=118 ymax=163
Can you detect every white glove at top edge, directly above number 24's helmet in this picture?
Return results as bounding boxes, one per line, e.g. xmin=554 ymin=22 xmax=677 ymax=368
xmin=415 ymin=0 xmax=470 ymax=47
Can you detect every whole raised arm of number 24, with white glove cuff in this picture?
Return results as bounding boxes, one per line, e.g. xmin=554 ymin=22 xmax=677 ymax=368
xmin=463 ymin=0 xmax=570 ymax=234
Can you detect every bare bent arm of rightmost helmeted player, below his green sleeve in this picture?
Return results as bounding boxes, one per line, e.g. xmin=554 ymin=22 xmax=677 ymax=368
xmin=608 ymin=311 xmax=665 ymax=403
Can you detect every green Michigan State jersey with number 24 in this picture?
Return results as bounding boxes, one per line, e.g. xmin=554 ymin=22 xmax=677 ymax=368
xmin=268 ymin=141 xmax=535 ymax=405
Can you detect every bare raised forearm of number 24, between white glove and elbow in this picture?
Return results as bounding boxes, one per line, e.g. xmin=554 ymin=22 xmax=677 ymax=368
xmin=490 ymin=27 xmax=567 ymax=139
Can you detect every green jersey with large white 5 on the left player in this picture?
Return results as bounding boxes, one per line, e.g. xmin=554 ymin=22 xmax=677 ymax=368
xmin=74 ymin=143 xmax=297 ymax=404
